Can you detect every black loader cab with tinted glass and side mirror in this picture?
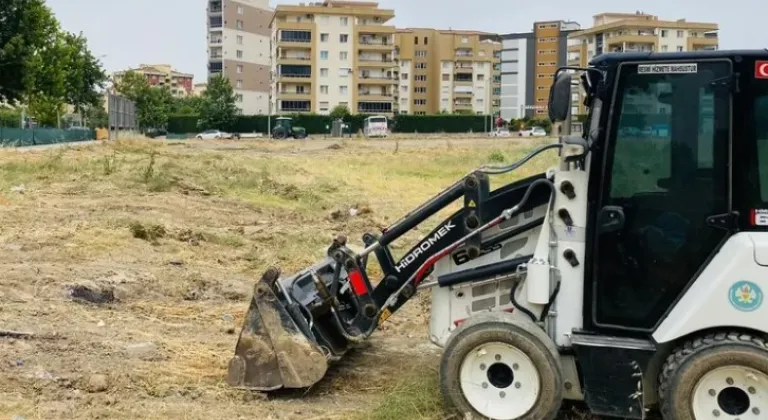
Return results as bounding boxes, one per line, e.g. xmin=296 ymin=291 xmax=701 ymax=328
xmin=550 ymin=51 xmax=768 ymax=337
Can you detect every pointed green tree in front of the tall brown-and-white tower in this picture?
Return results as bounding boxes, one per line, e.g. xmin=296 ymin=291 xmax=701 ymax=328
xmin=198 ymin=75 xmax=239 ymax=130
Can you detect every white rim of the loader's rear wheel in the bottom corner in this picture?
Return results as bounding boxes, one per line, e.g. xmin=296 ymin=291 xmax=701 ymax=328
xmin=692 ymin=366 xmax=768 ymax=420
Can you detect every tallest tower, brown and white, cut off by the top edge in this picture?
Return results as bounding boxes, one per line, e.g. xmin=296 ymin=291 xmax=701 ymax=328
xmin=206 ymin=0 xmax=273 ymax=115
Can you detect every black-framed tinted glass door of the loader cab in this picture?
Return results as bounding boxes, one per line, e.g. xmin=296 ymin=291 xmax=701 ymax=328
xmin=590 ymin=60 xmax=732 ymax=331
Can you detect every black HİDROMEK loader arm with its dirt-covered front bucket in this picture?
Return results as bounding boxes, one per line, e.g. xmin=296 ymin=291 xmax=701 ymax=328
xmin=228 ymin=138 xmax=586 ymax=390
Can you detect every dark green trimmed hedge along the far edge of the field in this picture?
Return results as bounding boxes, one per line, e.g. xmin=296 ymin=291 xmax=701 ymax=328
xmin=168 ymin=114 xmax=492 ymax=134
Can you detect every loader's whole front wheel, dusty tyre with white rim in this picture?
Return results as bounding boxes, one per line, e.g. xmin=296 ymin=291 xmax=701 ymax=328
xmin=440 ymin=322 xmax=563 ymax=420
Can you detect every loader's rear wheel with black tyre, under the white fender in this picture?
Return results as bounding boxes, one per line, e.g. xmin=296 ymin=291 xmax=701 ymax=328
xmin=659 ymin=332 xmax=768 ymax=420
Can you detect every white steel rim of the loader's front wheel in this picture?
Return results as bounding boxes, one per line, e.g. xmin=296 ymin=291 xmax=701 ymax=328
xmin=459 ymin=342 xmax=541 ymax=420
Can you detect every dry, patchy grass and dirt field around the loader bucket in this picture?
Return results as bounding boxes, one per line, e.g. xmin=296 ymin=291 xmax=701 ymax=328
xmin=0 ymin=138 xmax=592 ymax=420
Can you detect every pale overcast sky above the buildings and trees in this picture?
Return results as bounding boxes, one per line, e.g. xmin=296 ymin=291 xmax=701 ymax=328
xmin=46 ymin=0 xmax=768 ymax=82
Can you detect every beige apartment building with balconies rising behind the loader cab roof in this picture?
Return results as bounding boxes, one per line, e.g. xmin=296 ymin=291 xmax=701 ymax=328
xmin=568 ymin=12 xmax=719 ymax=115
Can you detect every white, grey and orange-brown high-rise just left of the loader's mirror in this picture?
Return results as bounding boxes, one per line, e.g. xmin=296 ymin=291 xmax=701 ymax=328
xmin=500 ymin=20 xmax=581 ymax=120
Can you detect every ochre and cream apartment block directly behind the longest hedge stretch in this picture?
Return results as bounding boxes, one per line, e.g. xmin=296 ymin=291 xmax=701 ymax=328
xmin=396 ymin=28 xmax=501 ymax=115
